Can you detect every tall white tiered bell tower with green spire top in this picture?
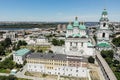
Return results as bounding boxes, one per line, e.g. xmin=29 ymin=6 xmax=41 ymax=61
xmin=97 ymin=9 xmax=111 ymax=50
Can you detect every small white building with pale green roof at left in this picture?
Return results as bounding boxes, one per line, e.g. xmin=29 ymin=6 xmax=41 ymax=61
xmin=13 ymin=48 xmax=31 ymax=64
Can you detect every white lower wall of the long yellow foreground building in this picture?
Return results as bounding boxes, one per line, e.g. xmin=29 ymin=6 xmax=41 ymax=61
xmin=27 ymin=63 xmax=89 ymax=77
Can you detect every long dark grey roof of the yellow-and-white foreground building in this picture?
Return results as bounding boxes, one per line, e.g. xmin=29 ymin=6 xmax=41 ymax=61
xmin=27 ymin=53 xmax=87 ymax=61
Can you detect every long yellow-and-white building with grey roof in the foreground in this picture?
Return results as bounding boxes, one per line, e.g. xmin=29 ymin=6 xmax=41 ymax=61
xmin=26 ymin=53 xmax=89 ymax=78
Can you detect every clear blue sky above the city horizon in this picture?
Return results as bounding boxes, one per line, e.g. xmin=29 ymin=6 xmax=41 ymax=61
xmin=0 ymin=0 xmax=120 ymax=22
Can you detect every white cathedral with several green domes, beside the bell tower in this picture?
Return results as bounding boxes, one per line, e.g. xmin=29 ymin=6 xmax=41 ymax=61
xmin=64 ymin=17 xmax=95 ymax=56
